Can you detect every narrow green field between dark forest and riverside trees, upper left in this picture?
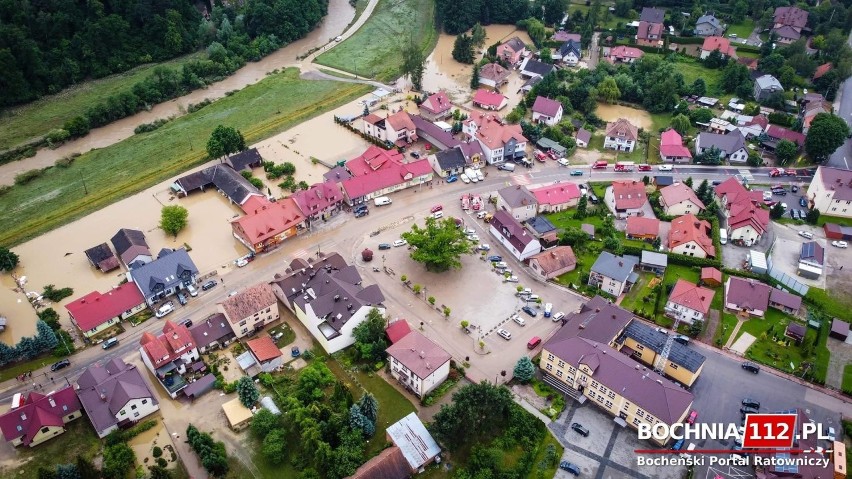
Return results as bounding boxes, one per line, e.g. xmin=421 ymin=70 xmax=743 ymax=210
xmin=0 ymin=54 xmax=201 ymax=151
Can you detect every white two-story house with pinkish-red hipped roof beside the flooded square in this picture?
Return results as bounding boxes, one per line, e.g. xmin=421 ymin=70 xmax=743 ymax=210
xmin=386 ymin=330 xmax=451 ymax=399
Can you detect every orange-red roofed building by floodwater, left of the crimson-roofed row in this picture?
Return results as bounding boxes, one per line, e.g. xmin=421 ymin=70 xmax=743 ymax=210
xmin=231 ymin=196 xmax=305 ymax=253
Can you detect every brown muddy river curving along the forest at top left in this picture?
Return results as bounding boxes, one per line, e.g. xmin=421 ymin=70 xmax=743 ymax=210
xmin=0 ymin=0 xmax=355 ymax=185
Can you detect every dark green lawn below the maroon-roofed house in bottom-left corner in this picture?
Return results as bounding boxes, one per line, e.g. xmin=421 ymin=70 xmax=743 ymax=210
xmin=0 ymin=417 xmax=101 ymax=479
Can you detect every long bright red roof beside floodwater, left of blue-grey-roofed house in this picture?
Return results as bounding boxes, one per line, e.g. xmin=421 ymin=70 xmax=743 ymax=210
xmin=65 ymin=282 xmax=145 ymax=331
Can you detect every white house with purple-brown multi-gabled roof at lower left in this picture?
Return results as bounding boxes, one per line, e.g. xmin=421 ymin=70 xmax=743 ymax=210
xmin=77 ymin=358 xmax=160 ymax=438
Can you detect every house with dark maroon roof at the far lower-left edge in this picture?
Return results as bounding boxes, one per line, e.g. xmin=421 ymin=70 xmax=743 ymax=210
xmin=0 ymin=386 xmax=83 ymax=447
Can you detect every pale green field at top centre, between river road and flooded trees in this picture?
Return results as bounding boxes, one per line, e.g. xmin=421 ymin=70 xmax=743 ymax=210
xmin=315 ymin=0 xmax=438 ymax=82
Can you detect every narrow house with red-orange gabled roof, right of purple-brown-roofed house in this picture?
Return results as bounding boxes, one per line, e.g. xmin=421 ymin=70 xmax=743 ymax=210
xmin=139 ymin=320 xmax=200 ymax=399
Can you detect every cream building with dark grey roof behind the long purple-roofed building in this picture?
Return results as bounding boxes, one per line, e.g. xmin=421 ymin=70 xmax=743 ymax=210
xmin=616 ymin=321 xmax=707 ymax=387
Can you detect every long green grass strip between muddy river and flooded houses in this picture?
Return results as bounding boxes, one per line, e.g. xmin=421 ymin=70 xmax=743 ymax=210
xmin=0 ymin=68 xmax=372 ymax=246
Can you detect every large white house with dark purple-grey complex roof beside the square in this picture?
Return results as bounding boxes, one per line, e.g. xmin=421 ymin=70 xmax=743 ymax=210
xmin=270 ymin=253 xmax=385 ymax=354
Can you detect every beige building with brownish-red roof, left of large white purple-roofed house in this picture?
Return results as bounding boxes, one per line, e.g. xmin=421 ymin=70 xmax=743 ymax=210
xmin=219 ymin=283 xmax=281 ymax=339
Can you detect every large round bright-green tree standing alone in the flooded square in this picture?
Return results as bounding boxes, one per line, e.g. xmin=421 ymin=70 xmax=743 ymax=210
xmin=401 ymin=217 xmax=470 ymax=272
